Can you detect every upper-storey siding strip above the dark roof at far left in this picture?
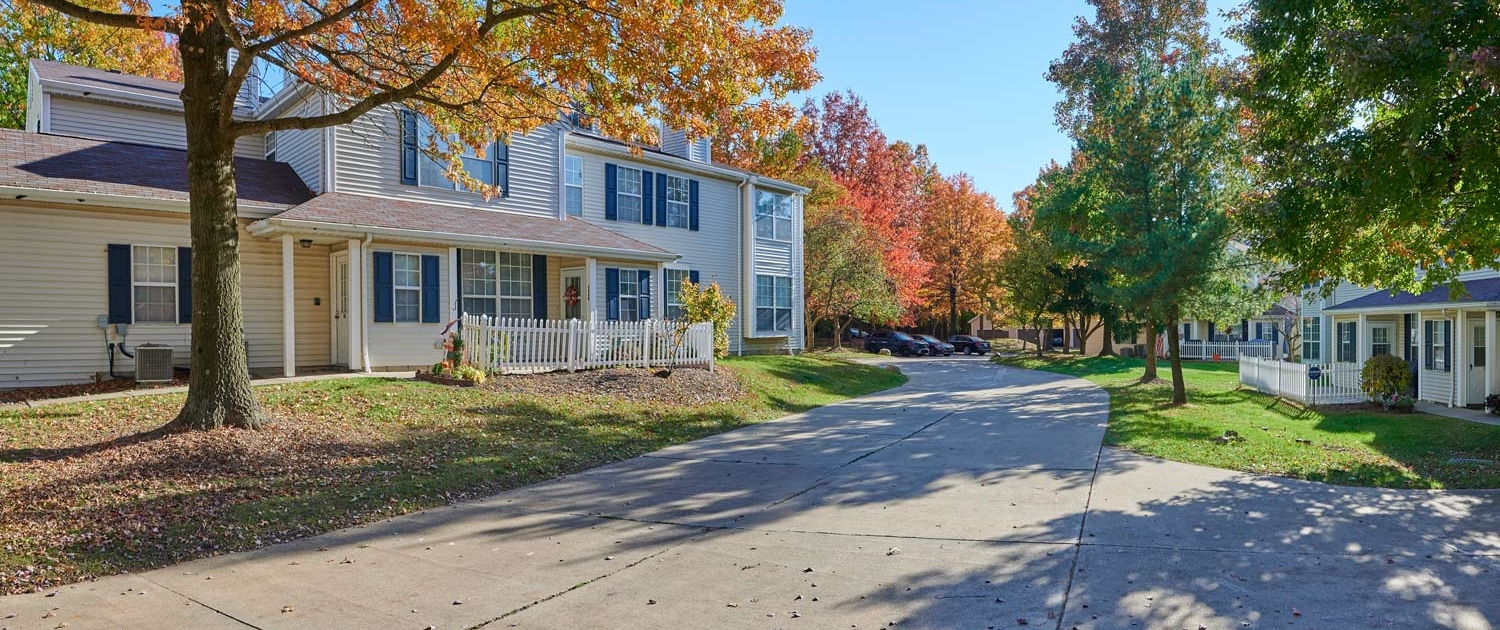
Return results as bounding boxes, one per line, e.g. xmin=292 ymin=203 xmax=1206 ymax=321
xmin=48 ymin=95 xmax=266 ymax=159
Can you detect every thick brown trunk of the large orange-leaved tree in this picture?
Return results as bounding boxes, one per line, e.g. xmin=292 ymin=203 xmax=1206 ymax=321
xmin=167 ymin=20 xmax=270 ymax=431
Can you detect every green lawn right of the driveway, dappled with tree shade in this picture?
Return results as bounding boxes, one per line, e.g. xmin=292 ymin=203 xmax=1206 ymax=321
xmin=996 ymin=356 xmax=1500 ymax=488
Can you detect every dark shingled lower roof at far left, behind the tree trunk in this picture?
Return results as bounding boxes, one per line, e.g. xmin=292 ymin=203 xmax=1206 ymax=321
xmin=0 ymin=129 xmax=314 ymax=212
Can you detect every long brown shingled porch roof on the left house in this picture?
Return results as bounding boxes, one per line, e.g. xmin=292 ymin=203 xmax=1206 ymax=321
xmin=251 ymin=192 xmax=678 ymax=261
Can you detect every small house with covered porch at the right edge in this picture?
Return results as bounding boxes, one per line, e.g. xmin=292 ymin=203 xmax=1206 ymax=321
xmin=1302 ymin=269 xmax=1500 ymax=407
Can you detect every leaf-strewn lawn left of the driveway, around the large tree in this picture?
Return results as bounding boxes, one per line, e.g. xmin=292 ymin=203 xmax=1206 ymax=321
xmin=0 ymin=356 xmax=906 ymax=594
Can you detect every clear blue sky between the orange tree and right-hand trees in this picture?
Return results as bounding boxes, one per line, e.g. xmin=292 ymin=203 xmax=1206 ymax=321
xmin=783 ymin=0 xmax=1236 ymax=209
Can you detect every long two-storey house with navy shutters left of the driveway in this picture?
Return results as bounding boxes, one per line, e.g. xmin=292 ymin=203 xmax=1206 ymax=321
xmin=0 ymin=60 xmax=807 ymax=387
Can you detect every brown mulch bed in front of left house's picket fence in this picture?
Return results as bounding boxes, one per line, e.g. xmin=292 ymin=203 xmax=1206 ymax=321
xmin=485 ymin=368 xmax=746 ymax=405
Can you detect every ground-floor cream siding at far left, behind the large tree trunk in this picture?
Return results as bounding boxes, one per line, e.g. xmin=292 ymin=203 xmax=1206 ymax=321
xmin=0 ymin=203 xmax=330 ymax=387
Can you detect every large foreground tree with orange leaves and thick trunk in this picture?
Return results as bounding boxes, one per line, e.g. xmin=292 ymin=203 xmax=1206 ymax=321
xmin=30 ymin=0 xmax=818 ymax=429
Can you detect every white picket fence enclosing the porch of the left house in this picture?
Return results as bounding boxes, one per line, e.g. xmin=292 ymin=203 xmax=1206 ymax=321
xmin=461 ymin=315 xmax=714 ymax=374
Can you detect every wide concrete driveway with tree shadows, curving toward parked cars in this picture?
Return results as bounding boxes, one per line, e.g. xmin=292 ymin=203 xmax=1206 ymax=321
xmin=0 ymin=357 xmax=1500 ymax=630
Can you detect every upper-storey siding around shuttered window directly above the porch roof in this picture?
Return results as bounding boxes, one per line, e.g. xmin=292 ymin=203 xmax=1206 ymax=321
xmin=333 ymin=108 xmax=563 ymax=216
